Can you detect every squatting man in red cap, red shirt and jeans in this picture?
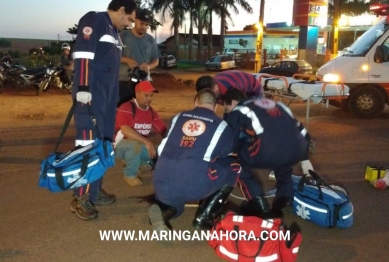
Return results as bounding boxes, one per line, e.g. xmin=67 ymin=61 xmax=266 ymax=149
xmin=114 ymin=81 xmax=167 ymax=186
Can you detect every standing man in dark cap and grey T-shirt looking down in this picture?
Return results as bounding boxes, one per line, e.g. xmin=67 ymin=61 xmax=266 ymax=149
xmin=118 ymin=9 xmax=159 ymax=107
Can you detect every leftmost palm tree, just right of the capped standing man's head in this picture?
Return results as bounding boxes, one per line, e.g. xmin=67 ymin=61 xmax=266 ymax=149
xmin=152 ymin=0 xmax=186 ymax=56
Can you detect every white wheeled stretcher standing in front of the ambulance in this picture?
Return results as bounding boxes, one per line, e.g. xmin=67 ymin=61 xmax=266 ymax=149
xmin=252 ymin=73 xmax=349 ymax=129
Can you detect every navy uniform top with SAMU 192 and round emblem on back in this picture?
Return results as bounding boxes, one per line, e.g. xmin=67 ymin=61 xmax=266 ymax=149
xmin=158 ymin=107 xmax=233 ymax=172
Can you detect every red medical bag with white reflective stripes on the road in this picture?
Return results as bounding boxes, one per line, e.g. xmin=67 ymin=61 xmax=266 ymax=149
xmin=208 ymin=212 xmax=302 ymax=262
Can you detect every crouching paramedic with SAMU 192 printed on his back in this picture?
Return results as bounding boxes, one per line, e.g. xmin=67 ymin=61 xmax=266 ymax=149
xmin=149 ymin=89 xmax=240 ymax=231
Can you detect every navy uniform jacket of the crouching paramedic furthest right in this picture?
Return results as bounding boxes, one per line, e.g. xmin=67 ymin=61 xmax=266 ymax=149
xmin=226 ymin=98 xmax=308 ymax=168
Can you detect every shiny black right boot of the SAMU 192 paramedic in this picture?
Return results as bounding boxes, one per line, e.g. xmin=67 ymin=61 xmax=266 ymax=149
xmin=193 ymin=185 xmax=234 ymax=229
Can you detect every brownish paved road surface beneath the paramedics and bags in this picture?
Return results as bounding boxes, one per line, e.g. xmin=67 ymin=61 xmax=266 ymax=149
xmin=0 ymin=79 xmax=389 ymax=262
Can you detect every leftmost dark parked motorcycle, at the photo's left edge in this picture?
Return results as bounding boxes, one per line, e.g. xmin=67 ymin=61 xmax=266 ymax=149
xmin=3 ymin=63 xmax=46 ymax=88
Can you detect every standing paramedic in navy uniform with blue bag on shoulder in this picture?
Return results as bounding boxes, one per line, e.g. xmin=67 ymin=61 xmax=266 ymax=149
xmin=70 ymin=0 xmax=137 ymax=220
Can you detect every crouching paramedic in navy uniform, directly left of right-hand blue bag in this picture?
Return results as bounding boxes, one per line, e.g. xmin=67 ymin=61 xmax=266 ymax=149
xmin=224 ymin=89 xmax=309 ymax=215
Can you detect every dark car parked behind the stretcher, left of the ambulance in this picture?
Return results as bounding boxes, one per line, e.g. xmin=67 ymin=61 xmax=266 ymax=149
xmin=259 ymin=58 xmax=313 ymax=76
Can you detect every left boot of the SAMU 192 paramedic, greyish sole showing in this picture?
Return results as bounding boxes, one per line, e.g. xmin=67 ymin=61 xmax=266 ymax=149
xmin=149 ymin=201 xmax=177 ymax=231
